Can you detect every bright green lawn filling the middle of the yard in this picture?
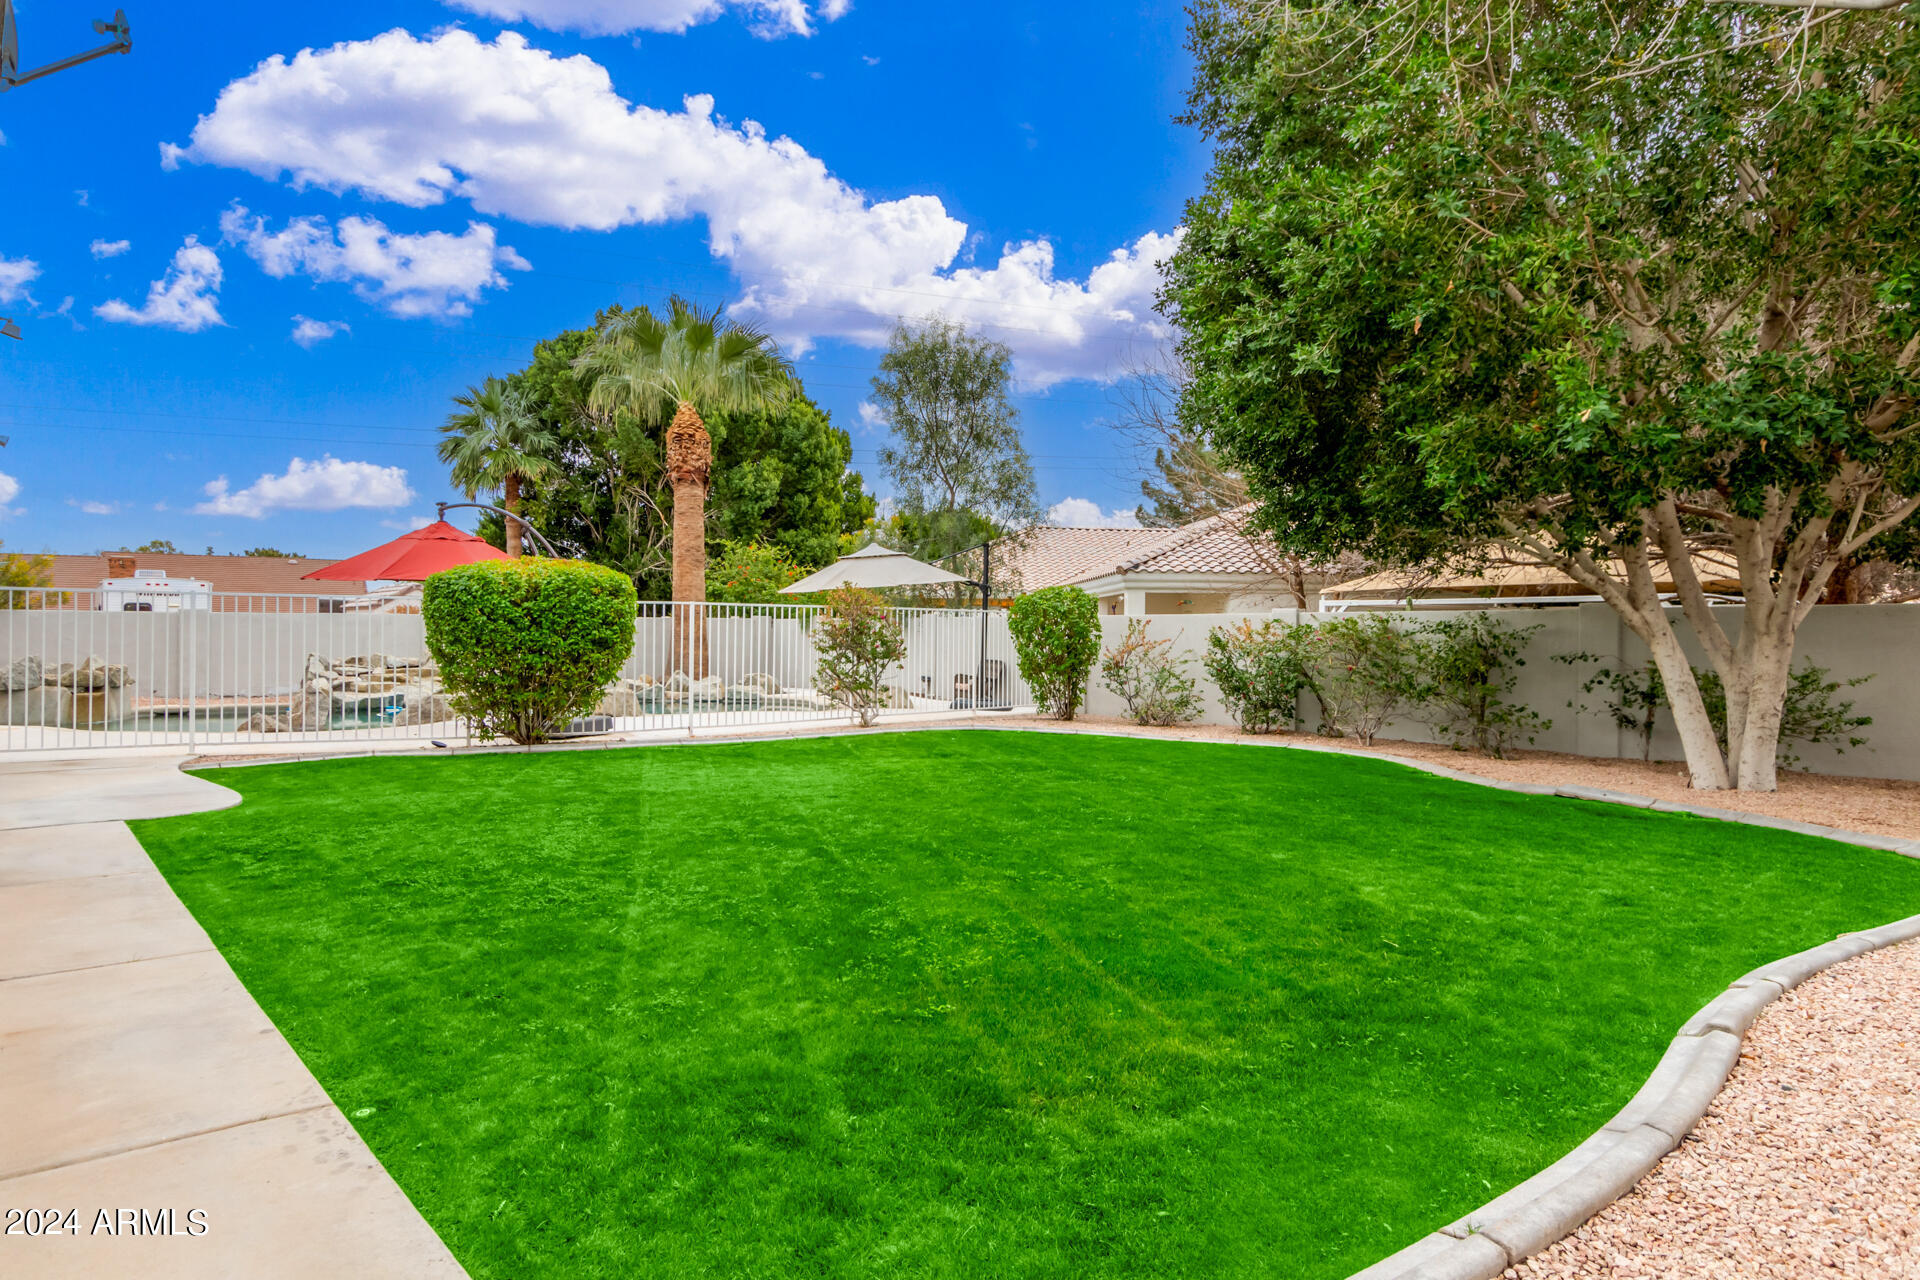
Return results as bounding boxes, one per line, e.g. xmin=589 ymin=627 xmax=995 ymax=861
xmin=136 ymin=731 xmax=1920 ymax=1280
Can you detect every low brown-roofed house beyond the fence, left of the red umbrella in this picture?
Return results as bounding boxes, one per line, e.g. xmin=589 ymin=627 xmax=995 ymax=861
xmin=48 ymin=551 xmax=367 ymax=614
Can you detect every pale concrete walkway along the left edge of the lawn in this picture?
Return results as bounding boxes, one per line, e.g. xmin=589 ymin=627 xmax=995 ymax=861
xmin=0 ymin=754 xmax=465 ymax=1280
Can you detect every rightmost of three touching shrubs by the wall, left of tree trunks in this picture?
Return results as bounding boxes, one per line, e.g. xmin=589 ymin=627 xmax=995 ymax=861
xmin=1413 ymin=614 xmax=1553 ymax=760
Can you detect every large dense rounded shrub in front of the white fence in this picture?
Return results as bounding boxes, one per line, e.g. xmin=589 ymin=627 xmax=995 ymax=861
xmin=420 ymin=558 xmax=636 ymax=743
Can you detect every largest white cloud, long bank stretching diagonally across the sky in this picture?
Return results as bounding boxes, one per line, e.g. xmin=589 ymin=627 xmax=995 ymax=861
xmin=161 ymin=29 xmax=1179 ymax=386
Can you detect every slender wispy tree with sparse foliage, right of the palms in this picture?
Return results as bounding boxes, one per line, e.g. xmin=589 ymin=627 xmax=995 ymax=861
xmin=874 ymin=317 xmax=1041 ymax=558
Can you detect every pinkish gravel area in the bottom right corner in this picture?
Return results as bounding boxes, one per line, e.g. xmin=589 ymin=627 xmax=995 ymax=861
xmin=1505 ymin=942 xmax=1920 ymax=1280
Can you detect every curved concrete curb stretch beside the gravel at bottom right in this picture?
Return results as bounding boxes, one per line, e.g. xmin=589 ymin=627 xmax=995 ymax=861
xmin=1348 ymin=915 xmax=1920 ymax=1280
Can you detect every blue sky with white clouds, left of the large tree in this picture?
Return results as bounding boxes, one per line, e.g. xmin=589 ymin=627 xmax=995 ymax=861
xmin=0 ymin=0 xmax=1206 ymax=555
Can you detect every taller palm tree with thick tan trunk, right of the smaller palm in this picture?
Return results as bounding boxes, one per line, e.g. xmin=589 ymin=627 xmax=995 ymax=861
xmin=574 ymin=297 xmax=793 ymax=606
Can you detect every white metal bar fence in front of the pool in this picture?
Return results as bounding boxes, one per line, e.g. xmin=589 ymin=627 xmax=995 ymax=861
xmin=0 ymin=587 xmax=1031 ymax=750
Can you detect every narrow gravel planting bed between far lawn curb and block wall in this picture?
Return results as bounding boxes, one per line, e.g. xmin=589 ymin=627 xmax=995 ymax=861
xmin=1027 ymin=718 xmax=1920 ymax=839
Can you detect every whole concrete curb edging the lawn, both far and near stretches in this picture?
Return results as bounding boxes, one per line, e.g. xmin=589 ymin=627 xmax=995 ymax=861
xmin=157 ymin=720 xmax=1920 ymax=1280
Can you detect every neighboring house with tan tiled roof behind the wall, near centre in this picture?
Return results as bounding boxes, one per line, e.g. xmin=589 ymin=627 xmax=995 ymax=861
xmin=993 ymin=505 xmax=1350 ymax=616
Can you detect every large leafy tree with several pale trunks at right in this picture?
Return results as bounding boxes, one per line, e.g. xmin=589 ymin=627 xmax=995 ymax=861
xmin=1165 ymin=0 xmax=1920 ymax=789
